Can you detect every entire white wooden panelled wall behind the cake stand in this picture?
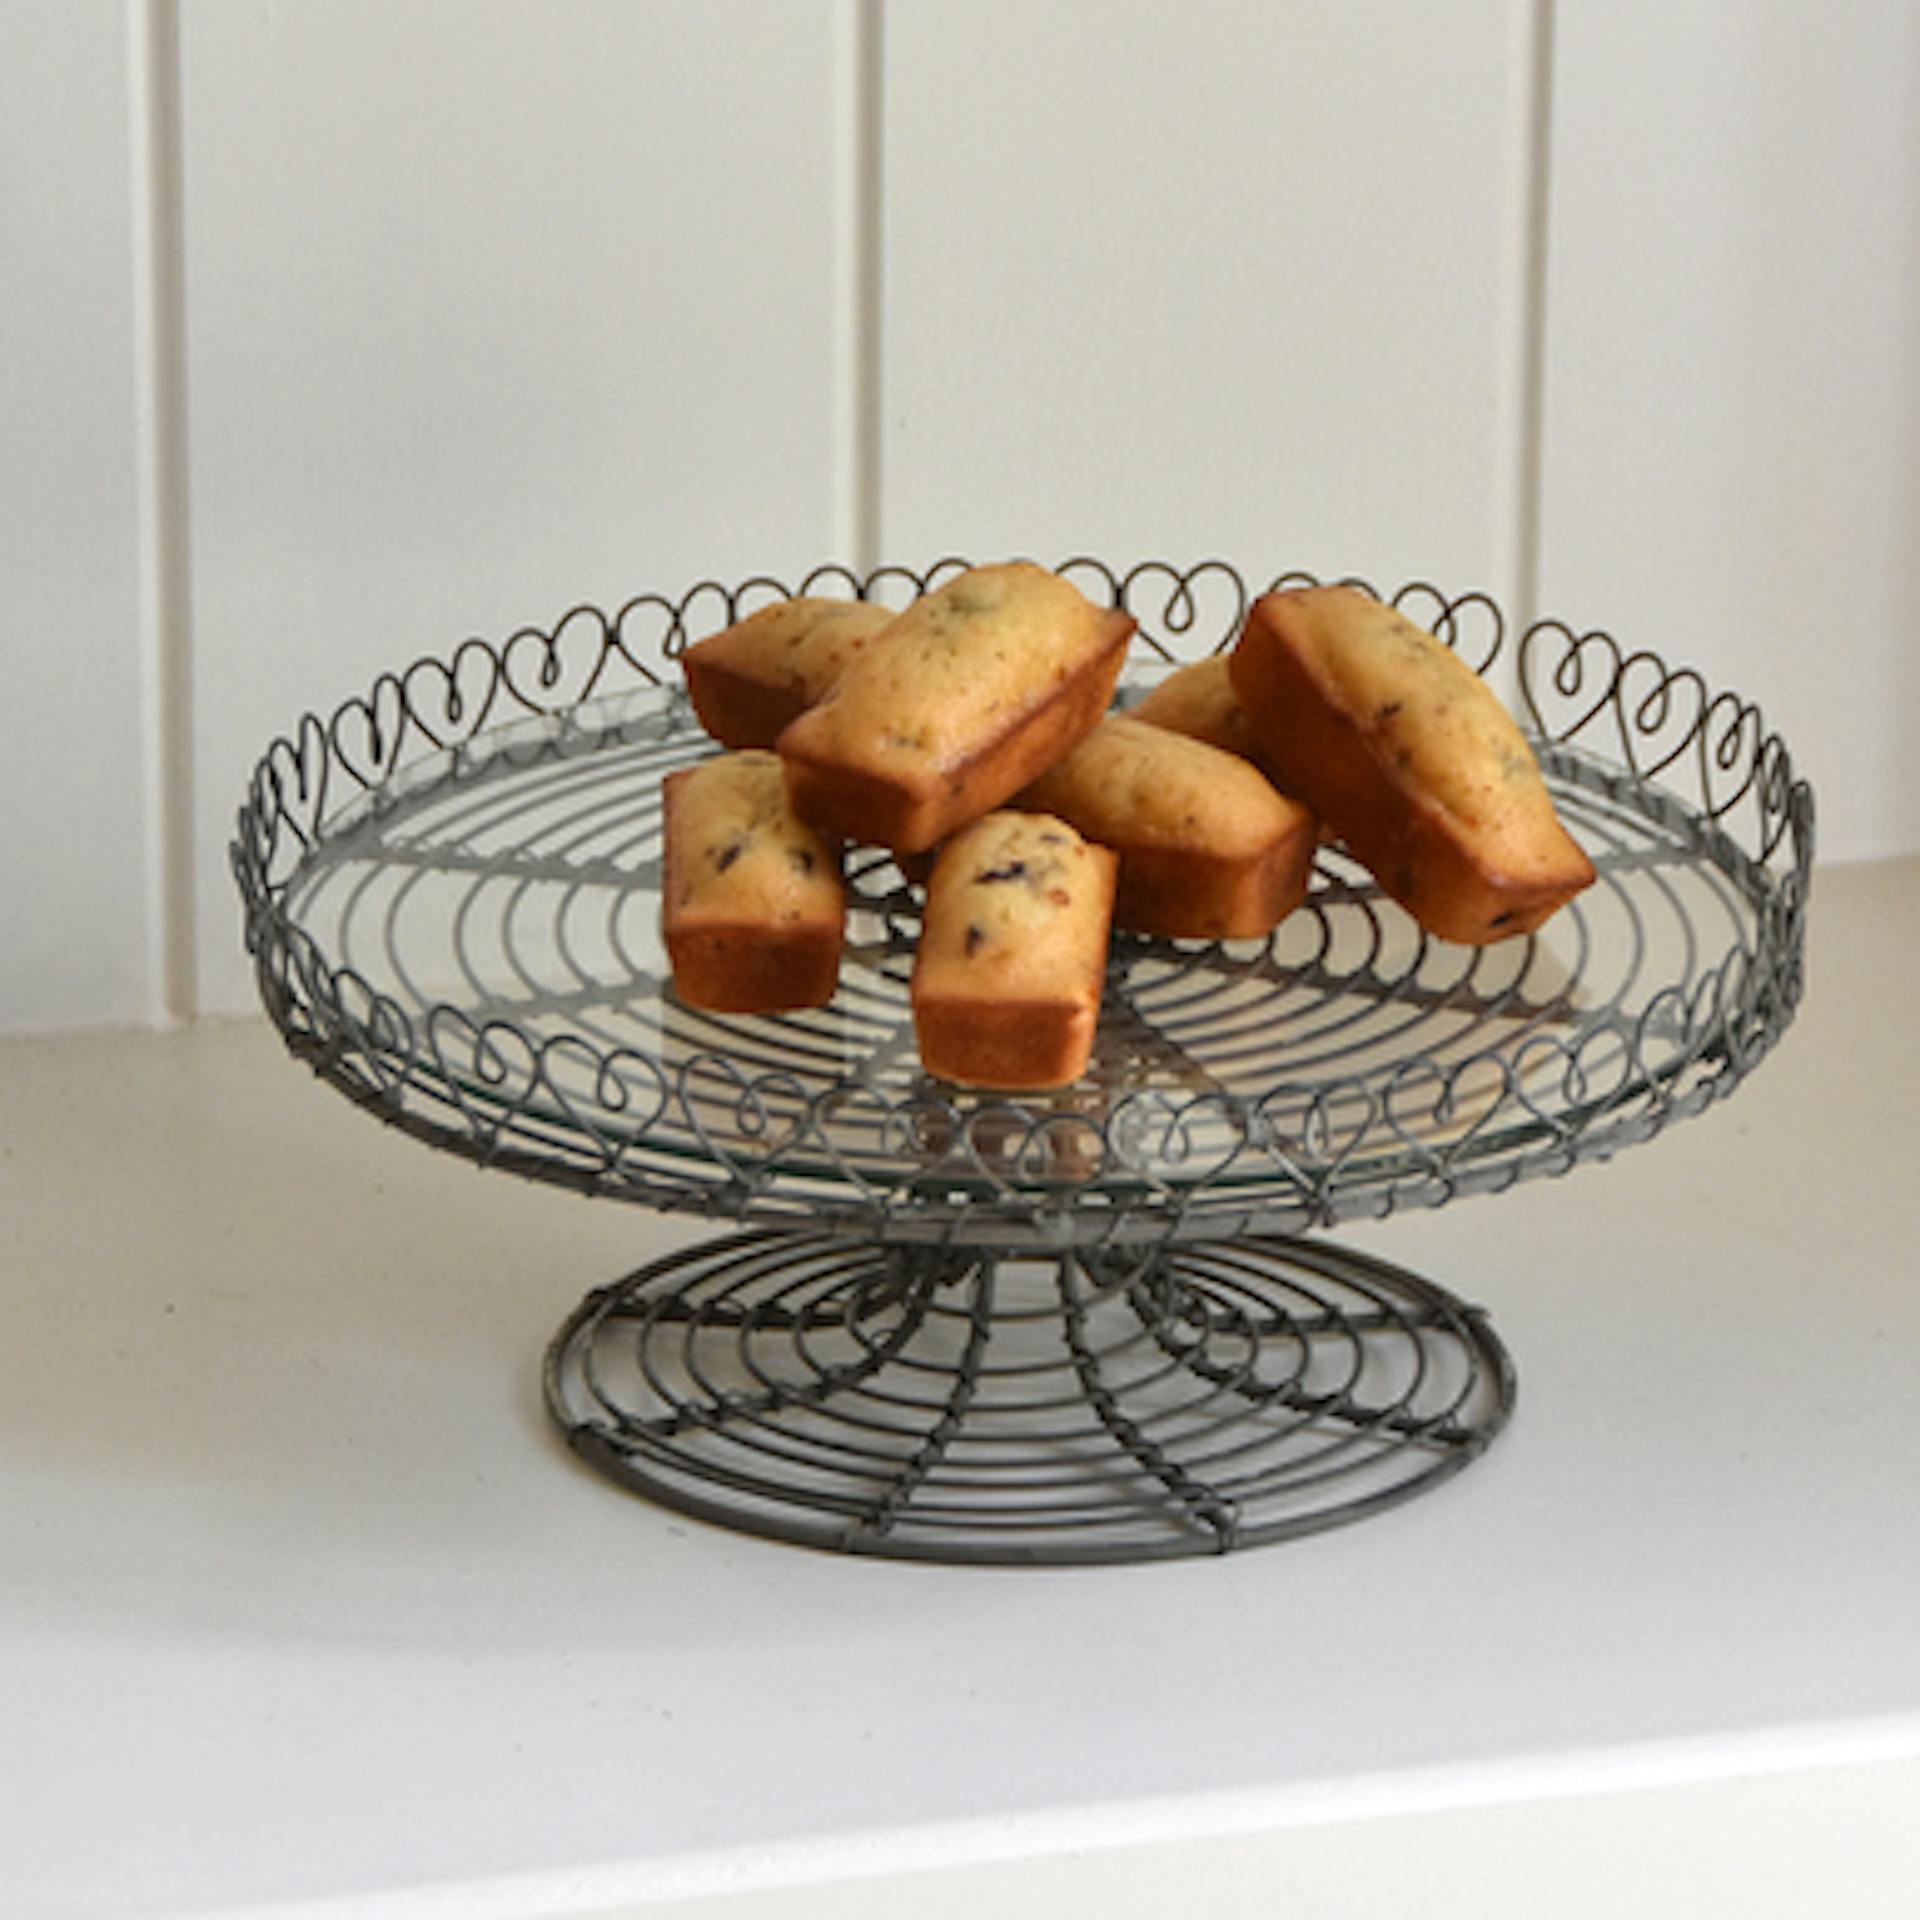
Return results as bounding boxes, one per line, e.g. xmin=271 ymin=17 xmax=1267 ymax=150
xmin=0 ymin=0 xmax=1920 ymax=1027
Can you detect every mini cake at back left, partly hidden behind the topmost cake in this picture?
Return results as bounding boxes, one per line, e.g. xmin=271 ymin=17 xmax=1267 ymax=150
xmin=680 ymin=595 xmax=893 ymax=747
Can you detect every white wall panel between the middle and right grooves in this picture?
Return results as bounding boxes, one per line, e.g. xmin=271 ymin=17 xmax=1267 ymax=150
xmin=881 ymin=0 xmax=1530 ymax=591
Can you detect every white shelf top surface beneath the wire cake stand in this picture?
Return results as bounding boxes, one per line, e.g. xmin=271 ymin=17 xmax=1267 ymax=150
xmin=0 ymin=860 xmax=1920 ymax=1920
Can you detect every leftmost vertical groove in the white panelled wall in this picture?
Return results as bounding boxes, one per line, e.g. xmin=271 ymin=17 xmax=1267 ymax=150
xmin=127 ymin=0 xmax=198 ymax=1021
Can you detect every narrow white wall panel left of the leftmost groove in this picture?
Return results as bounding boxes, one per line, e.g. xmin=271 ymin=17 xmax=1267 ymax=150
xmin=0 ymin=0 xmax=156 ymax=1027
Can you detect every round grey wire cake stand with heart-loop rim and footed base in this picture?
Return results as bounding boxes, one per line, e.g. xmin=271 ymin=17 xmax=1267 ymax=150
xmin=232 ymin=559 xmax=1812 ymax=1563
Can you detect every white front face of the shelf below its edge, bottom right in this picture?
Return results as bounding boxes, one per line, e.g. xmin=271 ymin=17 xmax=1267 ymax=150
xmin=618 ymin=1761 xmax=1920 ymax=1920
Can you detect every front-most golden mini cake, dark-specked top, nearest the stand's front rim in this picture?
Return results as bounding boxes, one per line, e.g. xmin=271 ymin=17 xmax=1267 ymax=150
xmin=912 ymin=812 xmax=1117 ymax=1091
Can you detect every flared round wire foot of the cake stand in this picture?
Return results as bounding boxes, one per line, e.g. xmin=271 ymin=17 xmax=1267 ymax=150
xmin=547 ymin=1233 xmax=1515 ymax=1565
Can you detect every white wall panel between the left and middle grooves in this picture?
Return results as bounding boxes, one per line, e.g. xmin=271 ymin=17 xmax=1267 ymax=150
xmin=182 ymin=0 xmax=845 ymax=1006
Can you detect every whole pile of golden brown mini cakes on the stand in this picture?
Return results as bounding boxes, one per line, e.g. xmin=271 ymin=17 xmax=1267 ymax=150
xmin=660 ymin=561 xmax=1594 ymax=1091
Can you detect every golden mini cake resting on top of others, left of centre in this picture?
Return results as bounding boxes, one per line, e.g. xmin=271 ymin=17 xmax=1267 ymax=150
xmin=780 ymin=561 xmax=1133 ymax=852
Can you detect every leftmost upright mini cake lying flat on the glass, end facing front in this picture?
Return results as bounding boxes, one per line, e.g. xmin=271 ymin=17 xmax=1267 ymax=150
xmin=660 ymin=751 xmax=847 ymax=1014
